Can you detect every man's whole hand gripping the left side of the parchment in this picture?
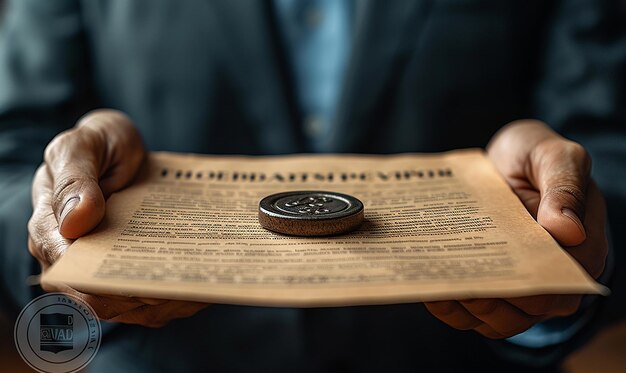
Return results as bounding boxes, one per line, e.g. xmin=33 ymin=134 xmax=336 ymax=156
xmin=28 ymin=110 xmax=206 ymax=327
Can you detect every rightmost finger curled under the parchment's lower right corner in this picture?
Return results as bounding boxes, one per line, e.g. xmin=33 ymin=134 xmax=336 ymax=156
xmin=505 ymin=295 xmax=582 ymax=317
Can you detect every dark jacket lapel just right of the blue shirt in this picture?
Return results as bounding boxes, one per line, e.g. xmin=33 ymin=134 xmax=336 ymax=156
xmin=331 ymin=0 xmax=432 ymax=152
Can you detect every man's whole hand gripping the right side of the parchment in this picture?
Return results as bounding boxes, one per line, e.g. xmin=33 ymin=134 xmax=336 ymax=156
xmin=426 ymin=120 xmax=608 ymax=339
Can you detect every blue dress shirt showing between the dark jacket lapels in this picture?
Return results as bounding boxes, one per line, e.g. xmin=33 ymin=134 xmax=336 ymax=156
xmin=274 ymin=0 xmax=354 ymax=152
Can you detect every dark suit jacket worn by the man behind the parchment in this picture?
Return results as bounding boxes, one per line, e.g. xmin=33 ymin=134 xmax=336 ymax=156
xmin=0 ymin=0 xmax=626 ymax=370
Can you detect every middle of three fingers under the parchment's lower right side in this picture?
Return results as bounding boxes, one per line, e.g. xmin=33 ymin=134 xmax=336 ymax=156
xmin=460 ymin=299 xmax=541 ymax=337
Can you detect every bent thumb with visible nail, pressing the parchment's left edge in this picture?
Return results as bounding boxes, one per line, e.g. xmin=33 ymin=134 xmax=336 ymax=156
xmin=45 ymin=111 xmax=143 ymax=238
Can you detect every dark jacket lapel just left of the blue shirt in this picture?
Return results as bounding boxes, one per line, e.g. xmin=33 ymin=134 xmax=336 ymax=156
xmin=211 ymin=0 xmax=303 ymax=154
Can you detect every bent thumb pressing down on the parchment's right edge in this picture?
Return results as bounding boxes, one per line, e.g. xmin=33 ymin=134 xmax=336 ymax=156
xmin=487 ymin=120 xmax=591 ymax=246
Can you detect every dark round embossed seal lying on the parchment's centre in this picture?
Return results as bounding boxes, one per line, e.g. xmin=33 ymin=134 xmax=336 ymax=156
xmin=259 ymin=191 xmax=364 ymax=236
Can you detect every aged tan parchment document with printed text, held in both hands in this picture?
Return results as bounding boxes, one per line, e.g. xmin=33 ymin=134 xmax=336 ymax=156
xmin=42 ymin=150 xmax=606 ymax=307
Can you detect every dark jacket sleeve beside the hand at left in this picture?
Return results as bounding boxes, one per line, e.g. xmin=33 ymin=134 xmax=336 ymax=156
xmin=0 ymin=0 xmax=92 ymax=316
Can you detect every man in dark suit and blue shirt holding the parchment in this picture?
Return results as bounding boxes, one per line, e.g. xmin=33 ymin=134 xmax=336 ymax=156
xmin=0 ymin=0 xmax=626 ymax=371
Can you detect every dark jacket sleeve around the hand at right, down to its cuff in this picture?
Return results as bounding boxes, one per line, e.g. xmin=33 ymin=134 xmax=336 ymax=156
xmin=494 ymin=0 xmax=626 ymax=365
